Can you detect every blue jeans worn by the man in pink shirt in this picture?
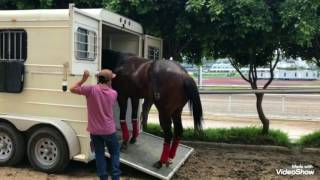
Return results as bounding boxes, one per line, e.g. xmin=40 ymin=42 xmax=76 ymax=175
xmin=90 ymin=133 xmax=121 ymax=180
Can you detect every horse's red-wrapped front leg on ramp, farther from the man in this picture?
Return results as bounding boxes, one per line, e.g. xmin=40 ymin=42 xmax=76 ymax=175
xmin=130 ymin=98 xmax=140 ymax=144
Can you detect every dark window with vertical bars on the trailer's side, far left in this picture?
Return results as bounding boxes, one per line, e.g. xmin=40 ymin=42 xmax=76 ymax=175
xmin=0 ymin=29 xmax=27 ymax=62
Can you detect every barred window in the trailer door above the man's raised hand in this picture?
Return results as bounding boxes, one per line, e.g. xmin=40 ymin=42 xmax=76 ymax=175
xmin=75 ymin=28 xmax=97 ymax=61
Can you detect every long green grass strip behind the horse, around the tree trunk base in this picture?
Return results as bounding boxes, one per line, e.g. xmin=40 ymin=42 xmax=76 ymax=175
xmin=145 ymin=124 xmax=291 ymax=147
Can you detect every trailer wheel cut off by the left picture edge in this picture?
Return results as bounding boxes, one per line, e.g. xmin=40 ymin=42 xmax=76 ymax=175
xmin=0 ymin=123 xmax=25 ymax=166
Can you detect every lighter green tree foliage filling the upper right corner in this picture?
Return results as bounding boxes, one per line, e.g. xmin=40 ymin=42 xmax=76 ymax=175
xmin=281 ymin=0 xmax=320 ymax=67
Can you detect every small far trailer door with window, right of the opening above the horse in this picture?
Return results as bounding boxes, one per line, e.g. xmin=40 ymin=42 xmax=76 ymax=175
xmin=143 ymin=35 xmax=162 ymax=60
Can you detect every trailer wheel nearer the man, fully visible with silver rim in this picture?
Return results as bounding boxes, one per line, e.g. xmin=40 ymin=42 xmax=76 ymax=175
xmin=28 ymin=127 xmax=69 ymax=173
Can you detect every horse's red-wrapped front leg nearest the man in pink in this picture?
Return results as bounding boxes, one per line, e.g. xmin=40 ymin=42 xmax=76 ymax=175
xmin=118 ymin=95 xmax=129 ymax=151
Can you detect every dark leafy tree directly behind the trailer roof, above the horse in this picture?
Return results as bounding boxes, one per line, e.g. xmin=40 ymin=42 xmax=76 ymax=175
xmin=103 ymin=0 xmax=202 ymax=63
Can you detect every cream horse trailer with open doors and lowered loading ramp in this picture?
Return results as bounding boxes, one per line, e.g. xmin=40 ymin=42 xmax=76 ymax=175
xmin=0 ymin=4 xmax=192 ymax=179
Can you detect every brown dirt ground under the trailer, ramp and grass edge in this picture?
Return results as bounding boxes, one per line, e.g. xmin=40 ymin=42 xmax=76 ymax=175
xmin=0 ymin=144 xmax=320 ymax=180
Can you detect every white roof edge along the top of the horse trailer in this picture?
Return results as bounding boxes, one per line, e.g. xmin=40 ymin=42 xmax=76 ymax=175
xmin=0 ymin=8 xmax=143 ymax=34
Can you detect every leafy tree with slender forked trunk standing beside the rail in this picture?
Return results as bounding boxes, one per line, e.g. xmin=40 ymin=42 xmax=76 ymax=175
xmin=187 ymin=0 xmax=289 ymax=134
